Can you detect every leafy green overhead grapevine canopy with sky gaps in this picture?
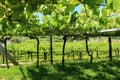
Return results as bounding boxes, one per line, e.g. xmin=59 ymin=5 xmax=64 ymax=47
xmin=0 ymin=0 xmax=120 ymax=36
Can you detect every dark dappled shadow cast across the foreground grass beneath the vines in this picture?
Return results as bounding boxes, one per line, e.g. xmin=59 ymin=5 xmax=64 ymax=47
xmin=24 ymin=61 xmax=120 ymax=80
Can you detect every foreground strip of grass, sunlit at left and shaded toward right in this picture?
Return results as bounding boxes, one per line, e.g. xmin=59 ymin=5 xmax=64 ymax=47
xmin=0 ymin=60 xmax=120 ymax=80
